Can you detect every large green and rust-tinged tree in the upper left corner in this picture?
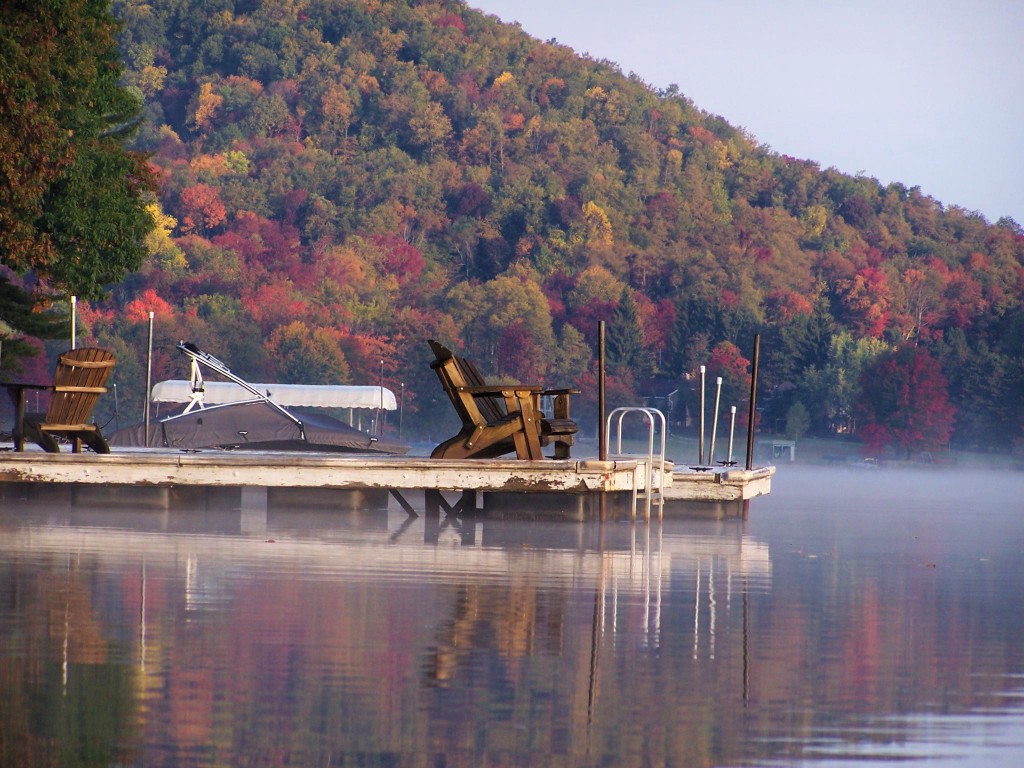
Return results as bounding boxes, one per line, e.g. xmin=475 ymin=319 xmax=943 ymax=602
xmin=0 ymin=0 xmax=155 ymax=370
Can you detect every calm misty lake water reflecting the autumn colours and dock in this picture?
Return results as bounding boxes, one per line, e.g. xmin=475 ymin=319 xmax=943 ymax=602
xmin=0 ymin=466 xmax=1024 ymax=768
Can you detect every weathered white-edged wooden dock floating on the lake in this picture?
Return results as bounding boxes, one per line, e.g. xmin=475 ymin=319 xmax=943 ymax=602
xmin=0 ymin=449 xmax=775 ymax=514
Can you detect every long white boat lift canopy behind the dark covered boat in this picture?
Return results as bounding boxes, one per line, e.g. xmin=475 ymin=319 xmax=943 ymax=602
xmin=151 ymin=379 xmax=398 ymax=411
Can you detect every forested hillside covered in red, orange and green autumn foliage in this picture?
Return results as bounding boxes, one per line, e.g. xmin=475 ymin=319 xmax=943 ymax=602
xmin=51 ymin=0 xmax=1024 ymax=451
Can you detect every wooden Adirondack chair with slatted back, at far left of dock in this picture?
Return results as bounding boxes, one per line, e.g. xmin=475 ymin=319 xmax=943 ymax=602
xmin=10 ymin=347 xmax=115 ymax=454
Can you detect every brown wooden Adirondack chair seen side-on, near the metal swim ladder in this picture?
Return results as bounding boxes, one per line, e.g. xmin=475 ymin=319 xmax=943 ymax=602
xmin=428 ymin=340 xmax=579 ymax=460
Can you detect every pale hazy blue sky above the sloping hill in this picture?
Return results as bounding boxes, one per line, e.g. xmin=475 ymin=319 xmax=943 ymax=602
xmin=469 ymin=0 xmax=1024 ymax=224
